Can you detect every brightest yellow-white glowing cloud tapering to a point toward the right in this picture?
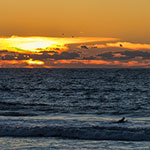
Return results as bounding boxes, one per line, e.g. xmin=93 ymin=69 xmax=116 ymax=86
xmin=0 ymin=36 xmax=118 ymax=53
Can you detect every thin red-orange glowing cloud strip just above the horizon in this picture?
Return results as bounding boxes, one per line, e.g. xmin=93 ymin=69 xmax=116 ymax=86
xmin=0 ymin=59 xmax=150 ymax=68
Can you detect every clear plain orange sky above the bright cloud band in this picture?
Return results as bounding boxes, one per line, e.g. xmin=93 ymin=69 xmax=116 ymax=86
xmin=0 ymin=0 xmax=150 ymax=43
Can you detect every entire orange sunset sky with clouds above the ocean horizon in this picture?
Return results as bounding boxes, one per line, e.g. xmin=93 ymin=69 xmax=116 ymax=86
xmin=0 ymin=0 xmax=150 ymax=68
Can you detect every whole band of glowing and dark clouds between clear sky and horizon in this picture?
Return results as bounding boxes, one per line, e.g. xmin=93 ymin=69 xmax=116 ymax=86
xmin=0 ymin=36 xmax=150 ymax=68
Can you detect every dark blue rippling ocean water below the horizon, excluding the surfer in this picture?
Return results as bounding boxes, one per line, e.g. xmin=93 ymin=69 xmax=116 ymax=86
xmin=0 ymin=69 xmax=150 ymax=150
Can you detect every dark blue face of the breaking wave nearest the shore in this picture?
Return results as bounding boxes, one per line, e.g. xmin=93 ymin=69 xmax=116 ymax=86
xmin=0 ymin=126 xmax=150 ymax=141
